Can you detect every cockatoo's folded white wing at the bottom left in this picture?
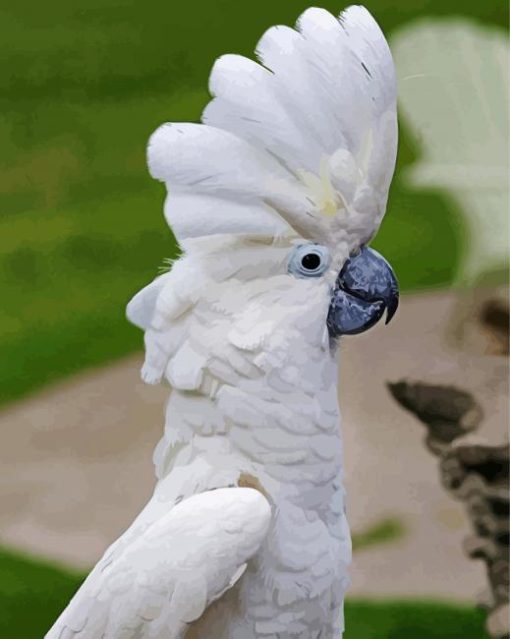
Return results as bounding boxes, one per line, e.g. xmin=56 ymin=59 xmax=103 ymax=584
xmin=46 ymin=488 xmax=271 ymax=639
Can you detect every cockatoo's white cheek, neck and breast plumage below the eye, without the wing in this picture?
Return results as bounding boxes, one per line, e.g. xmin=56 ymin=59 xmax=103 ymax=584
xmin=141 ymin=238 xmax=351 ymax=639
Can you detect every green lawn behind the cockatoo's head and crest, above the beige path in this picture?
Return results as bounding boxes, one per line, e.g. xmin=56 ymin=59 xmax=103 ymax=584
xmin=0 ymin=0 xmax=508 ymax=402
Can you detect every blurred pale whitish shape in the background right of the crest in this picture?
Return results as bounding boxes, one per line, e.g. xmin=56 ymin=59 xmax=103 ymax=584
xmin=391 ymin=19 xmax=510 ymax=285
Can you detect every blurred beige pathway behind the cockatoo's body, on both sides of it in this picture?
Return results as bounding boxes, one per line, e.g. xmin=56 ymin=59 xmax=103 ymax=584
xmin=0 ymin=294 xmax=502 ymax=599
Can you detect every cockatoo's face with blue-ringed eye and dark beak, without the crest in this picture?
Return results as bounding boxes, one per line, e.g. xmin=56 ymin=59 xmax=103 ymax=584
xmin=175 ymin=236 xmax=398 ymax=350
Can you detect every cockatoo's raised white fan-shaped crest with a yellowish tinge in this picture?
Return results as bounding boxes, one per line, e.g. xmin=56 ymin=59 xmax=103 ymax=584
xmin=148 ymin=6 xmax=397 ymax=257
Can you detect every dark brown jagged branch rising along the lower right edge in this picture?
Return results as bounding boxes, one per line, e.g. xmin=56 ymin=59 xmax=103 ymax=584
xmin=388 ymin=381 xmax=510 ymax=638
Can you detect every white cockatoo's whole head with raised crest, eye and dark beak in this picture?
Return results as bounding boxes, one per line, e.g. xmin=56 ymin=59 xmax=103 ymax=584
xmin=128 ymin=6 xmax=398 ymax=377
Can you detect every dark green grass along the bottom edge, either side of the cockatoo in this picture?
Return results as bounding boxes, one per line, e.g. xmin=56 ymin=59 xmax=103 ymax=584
xmin=0 ymin=550 xmax=487 ymax=639
